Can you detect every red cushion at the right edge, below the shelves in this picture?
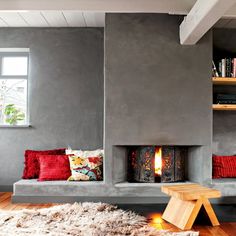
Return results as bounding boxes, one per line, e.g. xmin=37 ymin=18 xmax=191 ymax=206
xmin=212 ymin=155 xmax=236 ymax=179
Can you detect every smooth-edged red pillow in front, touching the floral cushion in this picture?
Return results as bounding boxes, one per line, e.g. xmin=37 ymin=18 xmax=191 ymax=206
xmin=37 ymin=155 xmax=71 ymax=181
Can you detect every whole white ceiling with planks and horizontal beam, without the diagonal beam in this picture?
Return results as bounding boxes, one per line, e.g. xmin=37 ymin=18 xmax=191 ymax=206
xmin=0 ymin=0 xmax=236 ymax=28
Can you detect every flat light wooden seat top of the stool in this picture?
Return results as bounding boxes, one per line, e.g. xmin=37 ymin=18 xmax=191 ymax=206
xmin=161 ymin=184 xmax=221 ymax=200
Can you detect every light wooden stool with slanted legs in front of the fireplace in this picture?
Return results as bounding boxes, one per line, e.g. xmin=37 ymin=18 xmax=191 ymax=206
xmin=161 ymin=184 xmax=221 ymax=230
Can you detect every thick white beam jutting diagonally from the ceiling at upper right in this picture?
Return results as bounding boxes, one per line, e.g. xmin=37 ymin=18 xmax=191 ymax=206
xmin=180 ymin=0 xmax=236 ymax=45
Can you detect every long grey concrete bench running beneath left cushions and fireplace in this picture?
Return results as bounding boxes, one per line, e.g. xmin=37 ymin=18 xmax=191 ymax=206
xmin=12 ymin=179 xmax=171 ymax=203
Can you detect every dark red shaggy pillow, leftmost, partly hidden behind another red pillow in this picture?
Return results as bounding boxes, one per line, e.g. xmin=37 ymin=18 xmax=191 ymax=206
xmin=22 ymin=148 xmax=65 ymax=179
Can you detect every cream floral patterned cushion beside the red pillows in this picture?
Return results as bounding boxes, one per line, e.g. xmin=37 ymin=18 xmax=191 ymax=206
xmin=68 ymin=155 xmax=103 ymax=181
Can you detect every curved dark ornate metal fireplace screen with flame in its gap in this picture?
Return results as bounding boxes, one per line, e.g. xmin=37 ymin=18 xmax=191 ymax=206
xmin=127 ymin=146 xmax=188 ymax=183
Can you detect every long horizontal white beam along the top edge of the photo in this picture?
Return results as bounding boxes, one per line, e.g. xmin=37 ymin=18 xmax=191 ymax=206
xmin=0 ymin=0 xmax=195 ymax=14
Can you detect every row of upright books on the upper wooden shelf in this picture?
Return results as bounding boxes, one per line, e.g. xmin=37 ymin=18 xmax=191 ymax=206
xmin=212 ymin=58 xmax=236 ymax=78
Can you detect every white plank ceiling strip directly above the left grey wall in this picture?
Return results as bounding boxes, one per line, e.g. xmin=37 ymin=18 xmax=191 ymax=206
xmin=0 ymin=11 xmax=105 ymax=27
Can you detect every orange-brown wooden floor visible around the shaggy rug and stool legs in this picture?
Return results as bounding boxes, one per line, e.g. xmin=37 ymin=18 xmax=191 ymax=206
xmin=0 ymin=193 xmax=236 ymax=236
